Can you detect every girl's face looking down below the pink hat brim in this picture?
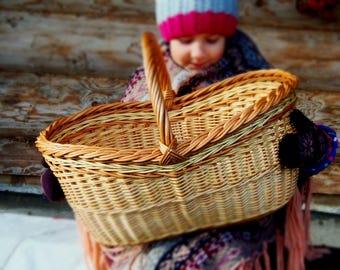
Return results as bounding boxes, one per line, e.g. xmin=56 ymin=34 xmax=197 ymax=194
xmin=170 ymin=34 xmax=226 ymax=73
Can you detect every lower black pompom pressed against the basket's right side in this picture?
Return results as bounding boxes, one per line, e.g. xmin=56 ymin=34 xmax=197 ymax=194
xmin=279 ymin=133 xmax=303 ymax=168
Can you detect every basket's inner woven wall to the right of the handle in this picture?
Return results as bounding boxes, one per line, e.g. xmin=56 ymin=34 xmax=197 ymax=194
xmin=170 ymin=82 xmax=280 ymax=142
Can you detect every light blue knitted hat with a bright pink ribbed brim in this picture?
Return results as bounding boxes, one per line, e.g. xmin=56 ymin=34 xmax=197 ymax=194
xmin=156 ymin=0 xmax=238 ymax=41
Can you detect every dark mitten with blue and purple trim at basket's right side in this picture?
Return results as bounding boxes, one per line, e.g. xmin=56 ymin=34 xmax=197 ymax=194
xmin=279 ymin=110 xmax=338 ymax=175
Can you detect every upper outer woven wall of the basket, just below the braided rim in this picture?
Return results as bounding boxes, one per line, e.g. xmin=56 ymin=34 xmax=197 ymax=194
xmin=48 ymin=112 xmax=291 ymax=210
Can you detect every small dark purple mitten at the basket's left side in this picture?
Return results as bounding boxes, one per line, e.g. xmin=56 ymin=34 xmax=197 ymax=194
xmin=40 ymin=169 xmax=65 ymax=202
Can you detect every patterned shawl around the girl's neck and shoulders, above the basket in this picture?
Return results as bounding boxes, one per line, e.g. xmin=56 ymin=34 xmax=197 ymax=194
xmin=121 ymin=30 xmax=270 ymax=102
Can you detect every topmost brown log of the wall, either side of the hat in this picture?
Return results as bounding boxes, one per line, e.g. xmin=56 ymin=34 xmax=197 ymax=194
xmin=0 ymin=0 xmax=340 ymax=31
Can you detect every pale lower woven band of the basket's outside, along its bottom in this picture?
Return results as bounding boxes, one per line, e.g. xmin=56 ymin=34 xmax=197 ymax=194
xmin=75 ymin=167 xmax=297 ymax=245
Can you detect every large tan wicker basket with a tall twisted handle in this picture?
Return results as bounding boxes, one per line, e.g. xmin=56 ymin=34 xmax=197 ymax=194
xmin=36 ymin=33 xmax=298 ymax=245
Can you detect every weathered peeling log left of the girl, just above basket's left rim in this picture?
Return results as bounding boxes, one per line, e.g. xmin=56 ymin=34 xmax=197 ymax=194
xmin=0 ymin=72 xmax=127 ymax=137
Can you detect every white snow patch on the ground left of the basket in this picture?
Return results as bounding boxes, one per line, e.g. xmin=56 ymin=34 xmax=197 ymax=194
xmin=0 ymin=213 xmax=86 ymax=270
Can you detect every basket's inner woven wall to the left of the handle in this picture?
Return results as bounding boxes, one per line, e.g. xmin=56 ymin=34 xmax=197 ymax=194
xmin=53 ymin=113 xmax=159 ymax=149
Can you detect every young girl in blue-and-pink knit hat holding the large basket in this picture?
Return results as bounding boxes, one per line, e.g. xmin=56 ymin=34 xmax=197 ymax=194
xmin=42 ymin=0 xmax=336 ymax=270
